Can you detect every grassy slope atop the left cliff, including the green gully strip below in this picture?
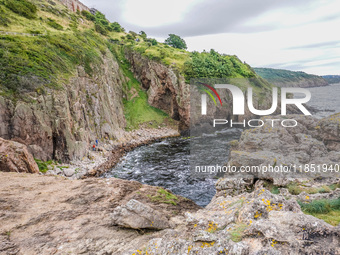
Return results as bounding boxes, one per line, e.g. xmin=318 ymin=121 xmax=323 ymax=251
xmin=0 ymin=1 xmax=168 ymax=129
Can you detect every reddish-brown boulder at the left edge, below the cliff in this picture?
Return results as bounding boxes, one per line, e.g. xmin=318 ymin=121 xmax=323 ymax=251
xmin=0 ymin=138 xmax=39 ymax=173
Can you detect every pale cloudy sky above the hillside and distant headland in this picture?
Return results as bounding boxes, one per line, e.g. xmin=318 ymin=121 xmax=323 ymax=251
xmin=81 ymin=0 xmax=340 ymax=75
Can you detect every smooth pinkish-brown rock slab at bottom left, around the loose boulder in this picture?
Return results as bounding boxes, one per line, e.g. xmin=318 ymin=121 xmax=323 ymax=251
xmin=0 ymin=172 xmax=200 ymax=255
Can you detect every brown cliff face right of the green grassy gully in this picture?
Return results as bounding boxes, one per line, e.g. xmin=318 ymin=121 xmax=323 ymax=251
xmin=126 ymin=51 xmax=190 ymax=130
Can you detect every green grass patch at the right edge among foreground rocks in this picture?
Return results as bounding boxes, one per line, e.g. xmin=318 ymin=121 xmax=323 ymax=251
xmin=298 ymin=197 xmax=340 ymax=226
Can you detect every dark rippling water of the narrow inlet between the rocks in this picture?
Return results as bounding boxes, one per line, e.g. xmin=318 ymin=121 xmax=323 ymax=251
xmin=103 ymin=129 xmax=241 ymax=206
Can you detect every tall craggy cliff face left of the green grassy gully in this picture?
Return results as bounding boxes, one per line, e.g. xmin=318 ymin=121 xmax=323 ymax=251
xmin=0 ymin=52 xmax=125 ymax=161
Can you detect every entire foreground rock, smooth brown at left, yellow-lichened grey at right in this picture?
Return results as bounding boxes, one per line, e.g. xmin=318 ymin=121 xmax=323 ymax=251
xmin=0 ymin=173 xmax=340 ymax=255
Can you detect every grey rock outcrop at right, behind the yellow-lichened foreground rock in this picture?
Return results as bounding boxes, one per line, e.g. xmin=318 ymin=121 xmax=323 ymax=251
xmin=223 ymin=114 xmax=340 ymax=187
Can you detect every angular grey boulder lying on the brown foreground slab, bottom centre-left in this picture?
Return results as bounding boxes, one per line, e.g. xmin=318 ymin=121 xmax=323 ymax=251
xmin=111 ymin=199 xmax=170 ymax=230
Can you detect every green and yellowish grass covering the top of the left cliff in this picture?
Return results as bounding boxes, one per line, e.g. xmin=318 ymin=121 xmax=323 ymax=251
xmin=0 ymin=0 xmax=106 ymax=96
